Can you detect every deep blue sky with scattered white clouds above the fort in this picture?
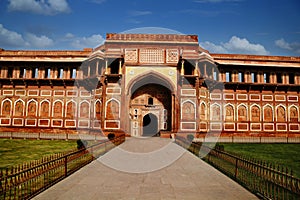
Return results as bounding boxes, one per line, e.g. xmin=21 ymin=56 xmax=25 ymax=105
xmin=0 ymin=0 xmax=300 ymax=56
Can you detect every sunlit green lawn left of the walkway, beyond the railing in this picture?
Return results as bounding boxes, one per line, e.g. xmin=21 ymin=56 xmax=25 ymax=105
xmin=0 ymin=139 xmax=77 ymax=168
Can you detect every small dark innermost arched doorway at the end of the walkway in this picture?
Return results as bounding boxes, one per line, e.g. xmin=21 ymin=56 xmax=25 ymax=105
xmin=143 ymin=113 xmax=158 ymax=137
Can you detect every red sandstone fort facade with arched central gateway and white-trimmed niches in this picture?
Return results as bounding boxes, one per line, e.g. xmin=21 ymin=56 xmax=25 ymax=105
xmin=0 ymin=34 xmax=300 ymax=137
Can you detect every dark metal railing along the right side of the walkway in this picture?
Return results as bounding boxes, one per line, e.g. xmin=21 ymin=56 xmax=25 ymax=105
xmin=175 ymin=138 xmax=300 ymax=199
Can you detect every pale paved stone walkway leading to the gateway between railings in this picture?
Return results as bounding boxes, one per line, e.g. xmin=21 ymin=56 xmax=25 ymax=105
xmin=34 ymin=138 xmax=257 ymax=200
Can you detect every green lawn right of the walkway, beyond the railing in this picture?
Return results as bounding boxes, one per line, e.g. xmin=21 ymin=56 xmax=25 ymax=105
xmin=222 ymin=143 xmax=300 ymax=178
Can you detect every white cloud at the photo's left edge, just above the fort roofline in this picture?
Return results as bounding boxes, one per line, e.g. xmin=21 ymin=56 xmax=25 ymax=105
xmin=0 ymin=24 xmax=29 ymax=48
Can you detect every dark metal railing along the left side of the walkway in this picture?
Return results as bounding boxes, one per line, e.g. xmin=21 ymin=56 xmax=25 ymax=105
xmin=0 ymin=135 xmax=125 ymax=199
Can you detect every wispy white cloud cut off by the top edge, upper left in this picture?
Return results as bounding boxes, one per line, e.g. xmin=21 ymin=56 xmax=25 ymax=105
xmin=8 ymin=0 xmax=71 ymax=15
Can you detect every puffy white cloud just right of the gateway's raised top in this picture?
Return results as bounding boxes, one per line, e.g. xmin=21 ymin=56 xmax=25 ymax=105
xmin=200 ymin=36 xmax=270 ymax=55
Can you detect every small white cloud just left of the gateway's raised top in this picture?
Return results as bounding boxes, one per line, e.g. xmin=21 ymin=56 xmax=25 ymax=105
xmin=70 ymin=34 xmax=104 ymax=49
